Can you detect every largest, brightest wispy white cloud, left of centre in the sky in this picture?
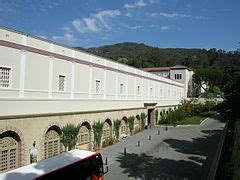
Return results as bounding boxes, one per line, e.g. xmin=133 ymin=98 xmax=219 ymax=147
xmin=72 ymin=10 xmax=121 ymax=33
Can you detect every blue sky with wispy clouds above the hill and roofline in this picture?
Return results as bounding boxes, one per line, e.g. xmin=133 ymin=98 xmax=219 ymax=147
xmin=0 ymin=0 xmax=240 ymax=51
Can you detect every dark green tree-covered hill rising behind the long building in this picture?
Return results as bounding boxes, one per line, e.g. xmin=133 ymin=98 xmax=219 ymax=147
xmin=75 ymin=42 xmax=240 ymax=69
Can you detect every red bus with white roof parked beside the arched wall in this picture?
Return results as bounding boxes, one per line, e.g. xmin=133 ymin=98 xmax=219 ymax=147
xmin=0 ymin=149 xmax=108 ymax=180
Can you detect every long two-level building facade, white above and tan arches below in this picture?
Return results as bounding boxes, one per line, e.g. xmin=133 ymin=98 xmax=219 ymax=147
xmin=0 ymin=27 xmax=185 ymax=172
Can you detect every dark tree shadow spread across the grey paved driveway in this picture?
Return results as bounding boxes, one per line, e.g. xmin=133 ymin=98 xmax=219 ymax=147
xmin=117 ymin=129 xmax=223 ymax=180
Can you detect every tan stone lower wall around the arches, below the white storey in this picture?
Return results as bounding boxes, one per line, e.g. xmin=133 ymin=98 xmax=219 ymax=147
xmin=0 ymin=108 xmax=147 ymax=165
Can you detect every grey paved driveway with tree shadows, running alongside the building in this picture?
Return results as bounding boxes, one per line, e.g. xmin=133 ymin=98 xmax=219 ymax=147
xmin=101 ymin=116 xmax=225 ymax=180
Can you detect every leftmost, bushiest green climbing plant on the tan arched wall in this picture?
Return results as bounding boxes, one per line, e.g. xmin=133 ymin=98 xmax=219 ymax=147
xmin=61 ymin=124 xmax=80 ymax=150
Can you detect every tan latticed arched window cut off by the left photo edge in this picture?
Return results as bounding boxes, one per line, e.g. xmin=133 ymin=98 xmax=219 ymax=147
xmin=0 ymin=131 xmax=20 ymax=172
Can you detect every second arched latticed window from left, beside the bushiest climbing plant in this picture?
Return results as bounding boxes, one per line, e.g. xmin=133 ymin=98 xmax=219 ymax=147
xmin=44 ymin=126 xmax=61 ymax=159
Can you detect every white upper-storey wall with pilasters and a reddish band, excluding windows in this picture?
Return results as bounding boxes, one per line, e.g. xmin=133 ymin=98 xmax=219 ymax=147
xmin=0 ymin=29 xmax=184 ymax=116
